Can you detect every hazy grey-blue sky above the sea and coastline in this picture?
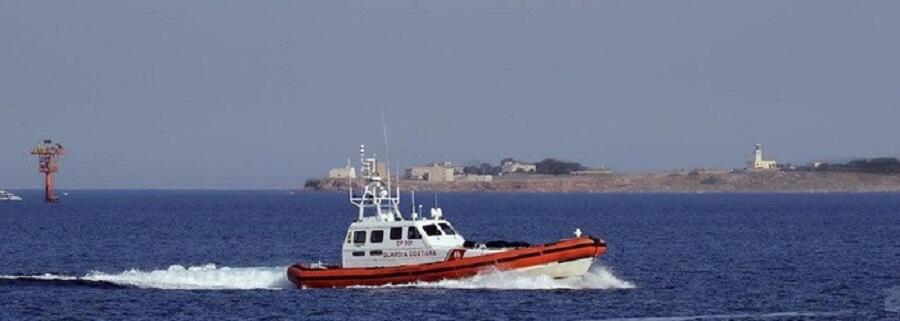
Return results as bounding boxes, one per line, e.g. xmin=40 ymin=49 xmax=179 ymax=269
xmin=0 ymin=0 xmax=900 ymax=189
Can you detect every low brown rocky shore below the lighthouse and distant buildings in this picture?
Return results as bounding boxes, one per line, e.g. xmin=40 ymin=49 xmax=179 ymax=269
xmin=305 ymin=171 xmax=900 ymax=193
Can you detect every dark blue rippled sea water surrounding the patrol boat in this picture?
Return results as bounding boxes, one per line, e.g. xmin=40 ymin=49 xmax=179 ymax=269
xmin=0 ymin=191 xmax=900 ymax=320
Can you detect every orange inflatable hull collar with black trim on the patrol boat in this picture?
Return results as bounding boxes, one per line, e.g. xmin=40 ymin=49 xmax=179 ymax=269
xmin=287 ymin=236 xmax=606 ymax=288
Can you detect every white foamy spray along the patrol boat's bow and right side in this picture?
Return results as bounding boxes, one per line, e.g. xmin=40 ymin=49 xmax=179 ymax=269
xmin=350 ymin=266 xmax=635 ymax=290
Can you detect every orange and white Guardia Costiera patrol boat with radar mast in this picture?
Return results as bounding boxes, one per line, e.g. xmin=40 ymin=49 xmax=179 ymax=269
xmin=287 ymin=146 xmax=606 ymax=288
